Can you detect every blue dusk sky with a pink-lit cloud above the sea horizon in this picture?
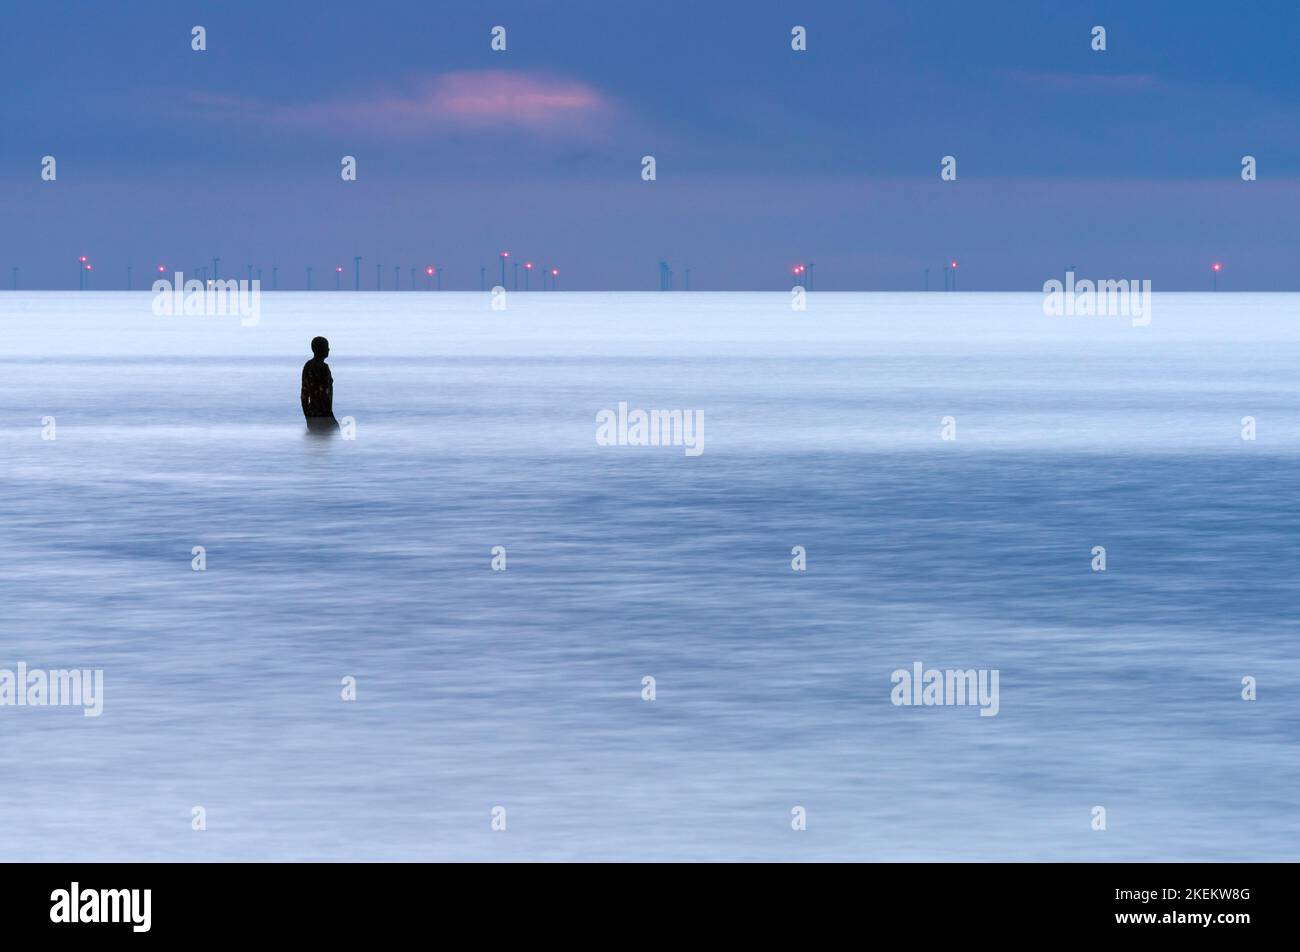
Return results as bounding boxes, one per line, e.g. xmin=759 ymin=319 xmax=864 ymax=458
xmin=0 ymin=0 xmax=1300 ymax=290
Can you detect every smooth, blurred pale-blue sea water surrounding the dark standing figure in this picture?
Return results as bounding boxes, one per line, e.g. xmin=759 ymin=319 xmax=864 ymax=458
xmin=0 ymin=294 xmax=1300 ymax=860
